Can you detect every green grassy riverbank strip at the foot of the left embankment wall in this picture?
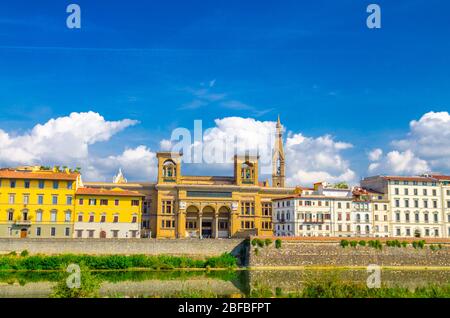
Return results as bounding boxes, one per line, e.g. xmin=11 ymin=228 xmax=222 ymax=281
xmin=0 ymin=253 xmax=237 ymax=271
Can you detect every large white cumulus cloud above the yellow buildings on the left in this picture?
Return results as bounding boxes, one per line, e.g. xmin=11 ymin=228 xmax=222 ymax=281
xmin=0 ymin=111 xmax=155 ymax=180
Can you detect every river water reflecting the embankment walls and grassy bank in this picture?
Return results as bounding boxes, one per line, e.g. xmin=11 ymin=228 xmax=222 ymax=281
xmin=0 ymin=269 xmax=450 ymax=297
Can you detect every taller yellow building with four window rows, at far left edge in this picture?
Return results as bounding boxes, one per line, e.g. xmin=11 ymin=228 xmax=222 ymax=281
xmin=0 ymin=167 xmax=81 ymax=238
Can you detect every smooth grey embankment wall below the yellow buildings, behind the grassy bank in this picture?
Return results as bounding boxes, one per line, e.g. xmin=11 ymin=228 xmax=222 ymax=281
xmin=0 ymin=239 xmax=244 ymax=256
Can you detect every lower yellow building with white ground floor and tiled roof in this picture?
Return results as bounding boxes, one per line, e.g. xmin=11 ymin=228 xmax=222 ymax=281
xmin=74 ymin=187 xmax=144 ymax=238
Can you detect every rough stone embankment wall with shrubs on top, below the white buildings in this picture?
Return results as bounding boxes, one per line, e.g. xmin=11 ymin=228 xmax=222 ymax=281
xmin=248 ymin=240 xmax=450 ymax=267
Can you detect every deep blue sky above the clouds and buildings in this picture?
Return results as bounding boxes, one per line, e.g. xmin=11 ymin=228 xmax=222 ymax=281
xmin=0 ymin=0 xmax=450 ymax=183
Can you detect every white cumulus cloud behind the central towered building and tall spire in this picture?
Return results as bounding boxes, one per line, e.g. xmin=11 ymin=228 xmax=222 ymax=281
xmin=164 ymin=117 xmax=357 ymax=186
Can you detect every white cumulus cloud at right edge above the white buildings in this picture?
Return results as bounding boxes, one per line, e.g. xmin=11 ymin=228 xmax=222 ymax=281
xmin=369 ymin=112 xmax=450 ymax=174
